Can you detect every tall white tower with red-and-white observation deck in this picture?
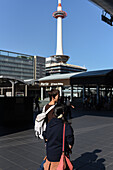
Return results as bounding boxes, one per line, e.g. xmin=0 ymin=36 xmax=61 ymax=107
xmin=53 ymin=0 xmax=69 ymax=63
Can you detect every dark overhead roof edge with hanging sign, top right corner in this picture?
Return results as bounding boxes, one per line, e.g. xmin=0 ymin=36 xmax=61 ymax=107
xmin=89 ymin=0 xmax=113 ymax=26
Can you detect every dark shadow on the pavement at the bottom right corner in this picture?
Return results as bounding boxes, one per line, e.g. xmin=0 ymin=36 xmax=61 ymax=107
xmin=72 ymin=149 xmax=105 ymax=170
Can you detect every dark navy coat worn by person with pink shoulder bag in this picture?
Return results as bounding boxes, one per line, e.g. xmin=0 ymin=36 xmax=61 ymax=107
xmin=44 ymin=118 xmax=74 ymax=162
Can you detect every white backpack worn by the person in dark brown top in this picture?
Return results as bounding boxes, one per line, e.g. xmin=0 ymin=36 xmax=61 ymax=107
xmin=34 ymin=105 xmax=55 ymax=139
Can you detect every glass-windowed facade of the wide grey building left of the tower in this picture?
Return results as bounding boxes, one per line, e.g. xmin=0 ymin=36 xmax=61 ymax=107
xmin=0 ymin=50 xmax=45 ymax=80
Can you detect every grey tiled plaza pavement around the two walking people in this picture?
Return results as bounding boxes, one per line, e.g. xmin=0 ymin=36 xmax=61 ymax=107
xmin=0 ymin=110 xmax=113 ymax=170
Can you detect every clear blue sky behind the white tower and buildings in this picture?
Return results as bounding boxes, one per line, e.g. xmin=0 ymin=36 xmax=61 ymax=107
xmin=0 ymin=0 xmax=113 ymax=70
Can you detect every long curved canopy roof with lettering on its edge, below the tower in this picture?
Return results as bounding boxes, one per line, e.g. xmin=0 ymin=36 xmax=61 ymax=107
xmin=39 ymin=69 xmax=113 ymax=86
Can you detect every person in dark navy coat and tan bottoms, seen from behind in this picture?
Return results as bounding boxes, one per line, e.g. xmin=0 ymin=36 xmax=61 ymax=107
xmin=43 ymin=104 xmax=74 ymax=170
